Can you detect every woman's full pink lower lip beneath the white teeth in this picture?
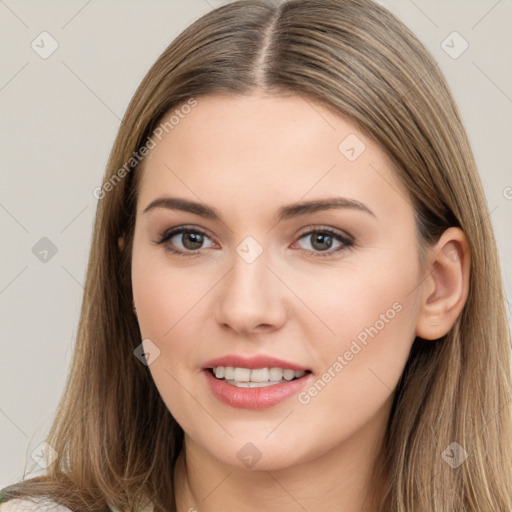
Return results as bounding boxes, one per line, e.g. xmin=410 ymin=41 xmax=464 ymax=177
xmin=203 ymin=370 xmax=313 ymax=409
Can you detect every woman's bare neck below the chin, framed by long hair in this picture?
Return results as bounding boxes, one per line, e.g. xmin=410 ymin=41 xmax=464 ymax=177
xmin=174 ymin=403 xmax=390 ymax=512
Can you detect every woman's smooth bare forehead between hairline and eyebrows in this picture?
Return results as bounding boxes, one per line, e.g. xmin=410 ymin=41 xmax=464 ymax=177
xmin=138 ymin=94 xmax=410 ymax=221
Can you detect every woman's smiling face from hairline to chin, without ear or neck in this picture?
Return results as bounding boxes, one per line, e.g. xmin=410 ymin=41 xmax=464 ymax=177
xmin=132 ymin=95 xmax=421 ymax=469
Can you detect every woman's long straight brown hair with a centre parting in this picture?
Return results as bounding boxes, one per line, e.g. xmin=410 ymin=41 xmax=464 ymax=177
xmin=3 ymin=0 xmax=512 ymax=512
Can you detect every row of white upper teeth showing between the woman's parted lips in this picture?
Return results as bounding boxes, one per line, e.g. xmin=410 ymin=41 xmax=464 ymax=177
xmin=213 ymin=366 xmax=306 ymax=388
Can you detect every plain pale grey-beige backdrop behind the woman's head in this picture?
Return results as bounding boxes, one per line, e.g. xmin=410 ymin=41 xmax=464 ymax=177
xmin=0 ymin=0 xmax=512 ymax=487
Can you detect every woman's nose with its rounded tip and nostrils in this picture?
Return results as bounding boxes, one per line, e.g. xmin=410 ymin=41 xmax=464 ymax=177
xmin=216 ymin=247 xmax=287 ymax=335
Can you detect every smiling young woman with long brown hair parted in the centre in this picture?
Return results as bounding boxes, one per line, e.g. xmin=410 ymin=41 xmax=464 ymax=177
xmin=1 ymin=0 xmax=512 ymax=512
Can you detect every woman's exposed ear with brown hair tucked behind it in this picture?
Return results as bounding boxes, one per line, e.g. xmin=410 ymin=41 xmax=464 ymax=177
xmin=416 ymin=227 xmax=471 ymax=340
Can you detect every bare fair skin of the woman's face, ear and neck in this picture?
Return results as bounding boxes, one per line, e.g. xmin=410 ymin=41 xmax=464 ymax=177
xmin=126 ymin=93 xmax=469 ymax=512
